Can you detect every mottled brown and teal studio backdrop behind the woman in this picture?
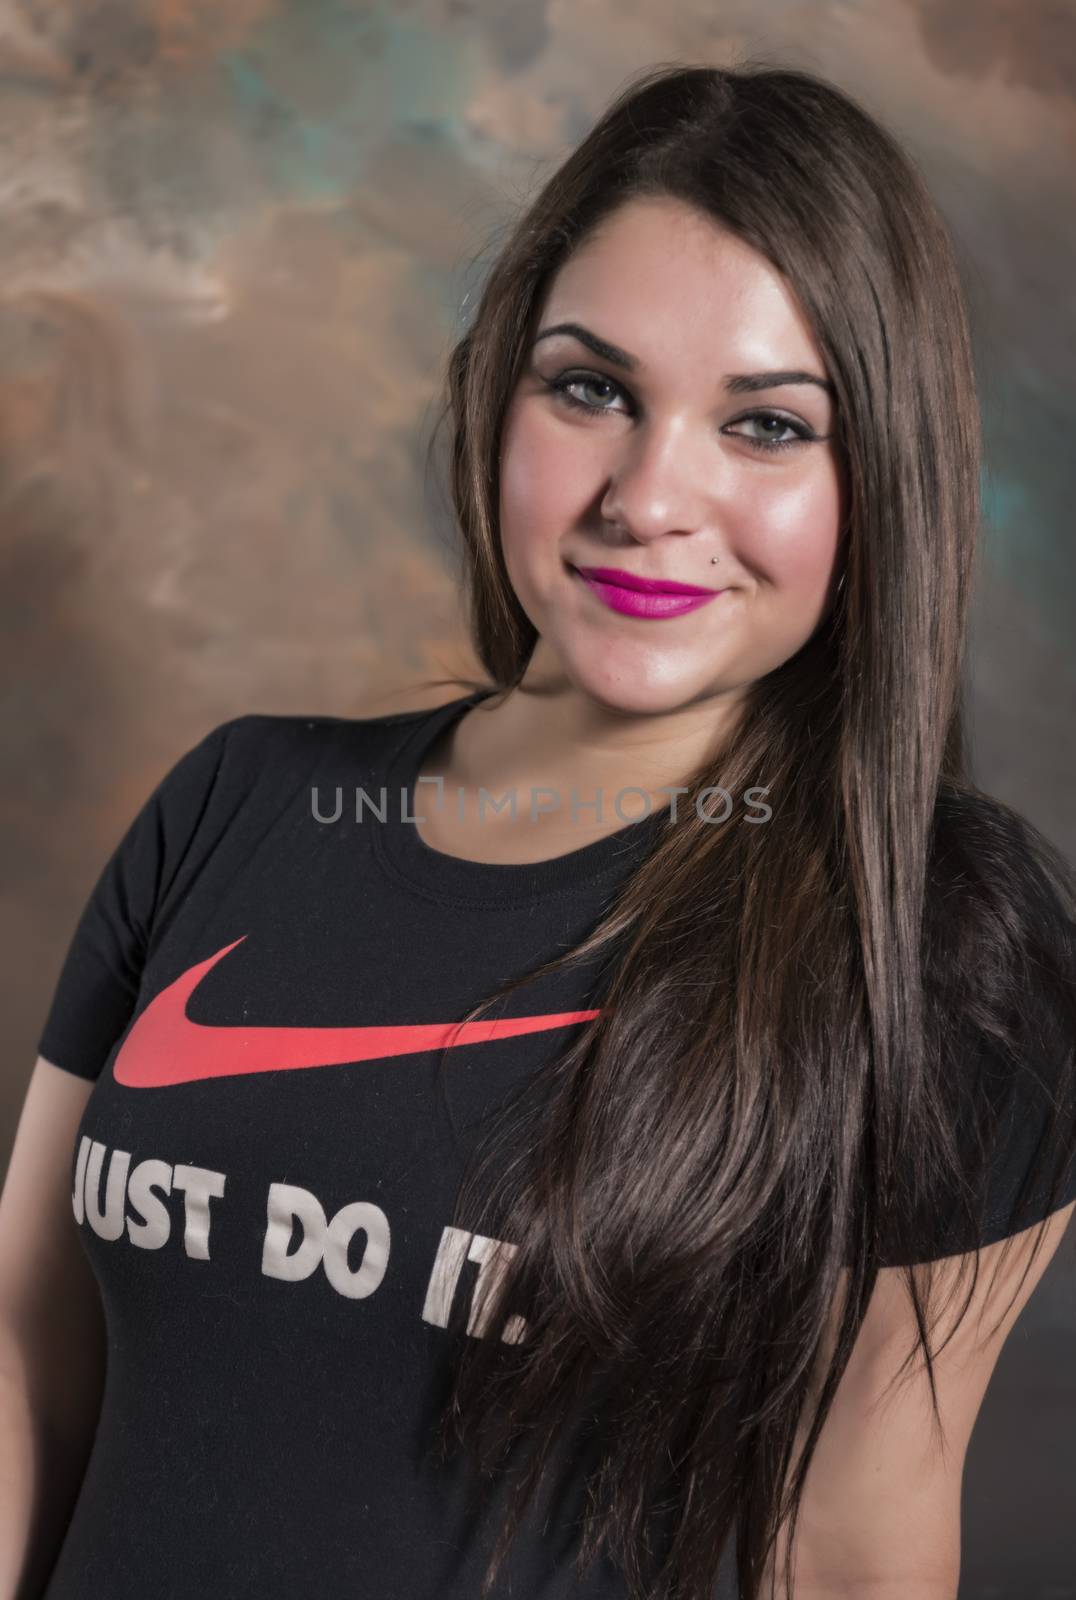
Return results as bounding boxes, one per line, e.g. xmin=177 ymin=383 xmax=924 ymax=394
xmin=0 ymin=0 xmax=1076 ymax=1600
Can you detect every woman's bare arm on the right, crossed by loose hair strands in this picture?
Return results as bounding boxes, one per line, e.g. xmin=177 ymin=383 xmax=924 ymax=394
xmin=761 ymin=1203 xmax=1076 ymax=1600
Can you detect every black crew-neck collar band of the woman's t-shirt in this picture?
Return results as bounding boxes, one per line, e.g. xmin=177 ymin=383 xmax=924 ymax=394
xmin=370 ymin=690 xmax=669 ymax=906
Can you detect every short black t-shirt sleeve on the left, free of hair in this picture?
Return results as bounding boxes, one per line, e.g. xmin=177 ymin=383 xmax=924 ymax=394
xmin=37 ymin=723 xmax=234 ymax=1078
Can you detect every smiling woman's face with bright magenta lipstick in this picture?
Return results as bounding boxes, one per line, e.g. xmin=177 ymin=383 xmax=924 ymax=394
xmin=500 ymin=198 xmax=844 ymax=712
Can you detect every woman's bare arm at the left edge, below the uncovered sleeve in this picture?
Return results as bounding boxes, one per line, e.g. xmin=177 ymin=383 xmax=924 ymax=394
xmin=0 ymin=1056 xmax=106 ymax=1600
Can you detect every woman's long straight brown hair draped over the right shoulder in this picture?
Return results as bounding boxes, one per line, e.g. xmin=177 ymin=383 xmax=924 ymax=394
xmin=413 ymin=62 xmax=1076 ymax=1600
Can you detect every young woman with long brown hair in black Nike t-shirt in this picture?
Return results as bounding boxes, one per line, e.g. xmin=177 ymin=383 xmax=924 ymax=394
xmin=0 ymin=56 xmax=1076 ymax=1600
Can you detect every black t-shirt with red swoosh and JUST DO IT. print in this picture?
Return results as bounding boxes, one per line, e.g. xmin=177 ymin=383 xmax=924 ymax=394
xmin=38 ymin=694 xmax=1076 ymax=1600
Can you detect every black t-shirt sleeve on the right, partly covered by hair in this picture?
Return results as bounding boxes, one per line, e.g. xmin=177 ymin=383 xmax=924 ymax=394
xmin=919 ymin=789 xmax=1076 ymax=1259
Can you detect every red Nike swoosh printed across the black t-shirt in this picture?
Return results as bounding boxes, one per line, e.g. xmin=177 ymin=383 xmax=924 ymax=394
xmin=112 ymin=934 xmax=599 ymax=1090
